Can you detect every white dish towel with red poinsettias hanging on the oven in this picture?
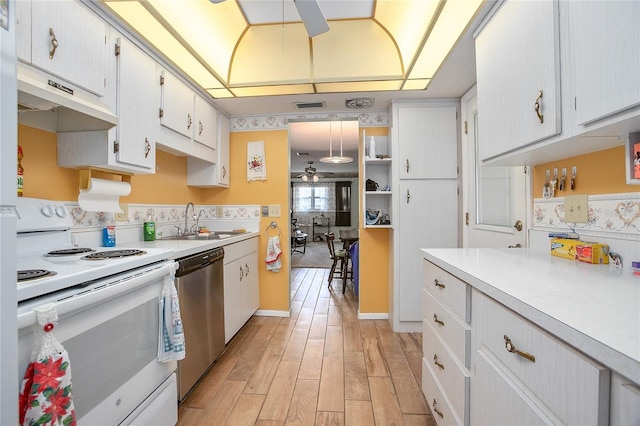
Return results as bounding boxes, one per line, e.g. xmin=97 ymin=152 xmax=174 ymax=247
xmin=18 ymin=303 xmax=76 ymax=426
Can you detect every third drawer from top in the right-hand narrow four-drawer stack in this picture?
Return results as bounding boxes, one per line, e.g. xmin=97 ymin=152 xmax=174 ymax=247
xmin=422 ymin=320 xmax=470 ymax=419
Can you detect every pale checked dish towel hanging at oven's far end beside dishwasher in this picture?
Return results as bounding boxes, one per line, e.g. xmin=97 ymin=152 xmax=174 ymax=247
xmin=158 ymin=263 xmax=185 ymax=362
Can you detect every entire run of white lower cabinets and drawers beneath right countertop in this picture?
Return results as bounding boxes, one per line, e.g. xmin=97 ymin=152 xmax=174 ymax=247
xmin=422 ymin=259 xmax=612 ymax=425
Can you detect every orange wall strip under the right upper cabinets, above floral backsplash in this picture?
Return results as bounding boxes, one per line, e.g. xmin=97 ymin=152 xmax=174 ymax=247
xmin=533 ymin=146 xmax=638 ymax=198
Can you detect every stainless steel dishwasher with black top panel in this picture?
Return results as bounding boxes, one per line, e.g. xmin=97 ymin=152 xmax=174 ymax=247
xmin=176 ymin=248 xmax=224 ymax=400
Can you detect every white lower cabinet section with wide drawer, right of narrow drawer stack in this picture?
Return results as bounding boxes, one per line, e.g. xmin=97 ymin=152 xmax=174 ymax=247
xmin=470 ymin=289 xmax=610 ymax=425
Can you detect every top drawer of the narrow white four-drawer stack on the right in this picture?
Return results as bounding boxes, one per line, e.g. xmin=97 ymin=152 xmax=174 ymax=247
xmin=423 ymin=260 xmax=471 ymax=323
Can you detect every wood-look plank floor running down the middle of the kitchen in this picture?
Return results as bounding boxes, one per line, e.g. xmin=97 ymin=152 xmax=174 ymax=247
xmin=178 ymin=268 xmax=436 ymax=426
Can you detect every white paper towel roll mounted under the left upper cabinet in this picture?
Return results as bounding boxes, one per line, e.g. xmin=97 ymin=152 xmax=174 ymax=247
xmin=78 ymin=178 xmax=131 ymax=213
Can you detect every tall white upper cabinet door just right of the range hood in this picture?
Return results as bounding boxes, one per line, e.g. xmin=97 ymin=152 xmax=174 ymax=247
xmin=117 ymin=37 xmax=158 ymax=173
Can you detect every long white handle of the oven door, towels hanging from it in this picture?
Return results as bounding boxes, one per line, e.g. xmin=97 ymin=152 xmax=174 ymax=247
xmin=18 ymin=262 xmax=178 ymax=330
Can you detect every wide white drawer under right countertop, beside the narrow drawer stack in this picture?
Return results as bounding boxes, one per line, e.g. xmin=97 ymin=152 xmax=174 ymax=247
xmin=472 ymin=291 xmax=610 ymax=424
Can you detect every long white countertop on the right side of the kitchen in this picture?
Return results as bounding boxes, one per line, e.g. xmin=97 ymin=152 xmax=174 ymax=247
xmin=422 ymin=248 xmax=640 ymax=384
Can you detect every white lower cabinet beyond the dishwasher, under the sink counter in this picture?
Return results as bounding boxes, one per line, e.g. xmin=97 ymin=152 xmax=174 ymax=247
xmin=224 ymin=237 xmax=260 ymax=343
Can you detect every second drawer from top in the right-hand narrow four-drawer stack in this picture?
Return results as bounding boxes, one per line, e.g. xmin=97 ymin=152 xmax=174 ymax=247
xmin=422 ymin=290 xmax=471 ymax=368
